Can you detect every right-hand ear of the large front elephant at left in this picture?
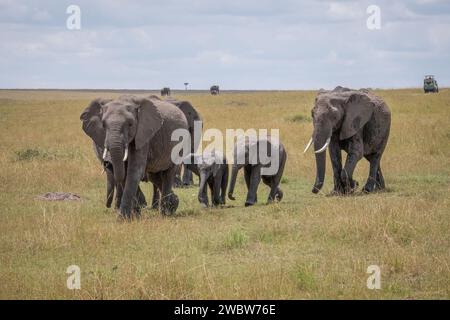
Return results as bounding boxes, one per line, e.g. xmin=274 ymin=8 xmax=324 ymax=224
xmin=134 ymin=98 xmax=163 ymax=150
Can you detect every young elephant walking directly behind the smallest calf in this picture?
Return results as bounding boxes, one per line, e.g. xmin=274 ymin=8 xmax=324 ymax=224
xmin=228 ymin=139 xmax=287 ymax=207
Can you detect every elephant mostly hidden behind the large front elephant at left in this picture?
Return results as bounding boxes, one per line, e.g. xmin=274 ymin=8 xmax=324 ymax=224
xmin=165 ymin=98 xmax=202 ymax=187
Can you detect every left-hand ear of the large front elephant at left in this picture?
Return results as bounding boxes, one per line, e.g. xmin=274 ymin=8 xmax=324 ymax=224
xmin=80 ymin=99 xmax=111 ymax=147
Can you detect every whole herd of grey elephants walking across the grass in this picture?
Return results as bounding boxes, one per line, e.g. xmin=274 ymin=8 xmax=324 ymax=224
xmin=80 ymin=87 xmax=391 ymax=219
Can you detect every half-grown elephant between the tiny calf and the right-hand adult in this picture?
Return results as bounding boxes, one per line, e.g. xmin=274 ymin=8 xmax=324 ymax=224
xmin=228 ymin=137 xmax=287 ymax=207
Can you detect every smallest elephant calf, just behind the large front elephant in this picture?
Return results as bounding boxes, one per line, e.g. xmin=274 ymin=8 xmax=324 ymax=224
xmin=183 ymin=151 xmax=228 ymax=208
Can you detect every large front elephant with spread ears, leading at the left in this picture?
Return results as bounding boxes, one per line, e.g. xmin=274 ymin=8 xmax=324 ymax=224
xmin=80 ymin=95 xmax=187 ymax=219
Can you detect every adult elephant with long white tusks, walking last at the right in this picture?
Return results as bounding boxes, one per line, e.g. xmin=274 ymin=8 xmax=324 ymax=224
xmin=305 ymin=87 xmax=391 ymax=194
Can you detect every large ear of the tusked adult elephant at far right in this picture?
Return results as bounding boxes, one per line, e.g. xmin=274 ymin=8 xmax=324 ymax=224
xmin=339 ymin=93 xmax=375 ymax=140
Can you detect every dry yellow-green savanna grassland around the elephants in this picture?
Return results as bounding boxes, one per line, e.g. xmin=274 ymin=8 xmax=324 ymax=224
xmin=0 ymin=89 xmax=450 ymax=299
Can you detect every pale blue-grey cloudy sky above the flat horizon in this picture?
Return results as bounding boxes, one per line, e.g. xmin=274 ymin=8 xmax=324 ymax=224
xmin=0 ymin=0 xmax=450 ymax=90
